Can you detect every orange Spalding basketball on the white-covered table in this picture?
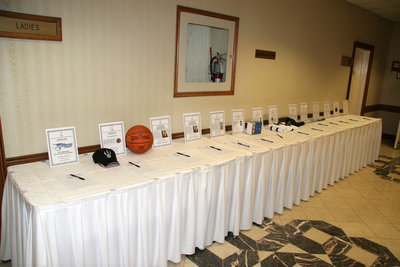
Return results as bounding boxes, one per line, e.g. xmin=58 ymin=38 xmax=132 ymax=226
xmin=125 ymin=125 xmax=153 ymax=153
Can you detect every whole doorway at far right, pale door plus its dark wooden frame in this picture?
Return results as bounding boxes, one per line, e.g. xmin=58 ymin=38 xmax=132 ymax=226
xmin=346 ymin=42 xmax=375 ymax=115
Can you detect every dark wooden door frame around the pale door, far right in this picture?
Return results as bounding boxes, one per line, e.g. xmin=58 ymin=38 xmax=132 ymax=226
xmin=346 ymin=41 xmax=375 ymax=115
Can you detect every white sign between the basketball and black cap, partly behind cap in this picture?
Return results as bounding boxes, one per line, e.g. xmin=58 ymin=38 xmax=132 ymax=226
xmin=99 ymin=121 xmax=126 ymax=156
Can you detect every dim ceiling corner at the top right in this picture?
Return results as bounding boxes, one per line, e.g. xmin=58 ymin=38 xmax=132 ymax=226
xmin=346 ymin=0 xmax=400 ymax=22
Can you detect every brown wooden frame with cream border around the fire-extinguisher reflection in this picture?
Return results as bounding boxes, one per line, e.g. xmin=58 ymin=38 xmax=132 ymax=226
xmin=174 ymin=6 xmax=239 ymax=97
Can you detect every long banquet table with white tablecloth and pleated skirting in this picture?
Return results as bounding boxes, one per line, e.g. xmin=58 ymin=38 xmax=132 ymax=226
xmin=0 ymin=115 xmax=382 ymax=267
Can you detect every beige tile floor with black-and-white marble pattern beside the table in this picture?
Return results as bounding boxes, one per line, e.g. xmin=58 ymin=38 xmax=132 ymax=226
xmin=168 ymin=140 xmax=400 ymax=267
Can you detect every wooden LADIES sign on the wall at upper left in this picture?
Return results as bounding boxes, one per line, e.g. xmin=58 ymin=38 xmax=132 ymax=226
xmin=0 ymin=10 xmax=62 ymax=41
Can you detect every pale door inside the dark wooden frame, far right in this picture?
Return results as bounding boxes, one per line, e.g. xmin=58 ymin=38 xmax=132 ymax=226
xmin=349 ymin=47 xmax=371 ymax=115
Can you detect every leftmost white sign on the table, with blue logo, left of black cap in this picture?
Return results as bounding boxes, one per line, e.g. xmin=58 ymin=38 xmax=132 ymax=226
xmin=46 ymin=127 xmax=79 ymax=168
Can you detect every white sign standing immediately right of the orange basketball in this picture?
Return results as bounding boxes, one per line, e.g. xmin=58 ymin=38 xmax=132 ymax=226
xmin=150 ymin=116 xmax=172 ymax=148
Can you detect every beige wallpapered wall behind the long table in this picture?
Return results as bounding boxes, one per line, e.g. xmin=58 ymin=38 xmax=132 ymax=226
xmin=0 ymin=0 xmax=392 ymax=157
